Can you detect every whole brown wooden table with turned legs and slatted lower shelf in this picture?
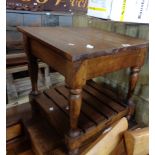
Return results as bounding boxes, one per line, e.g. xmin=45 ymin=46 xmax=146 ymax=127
xmin=18 ymin=27 xmax=148 ymax=154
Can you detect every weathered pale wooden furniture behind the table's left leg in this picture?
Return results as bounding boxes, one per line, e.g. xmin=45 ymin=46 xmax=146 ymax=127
xmin=6 ymin=53 xmax=51 ymax=104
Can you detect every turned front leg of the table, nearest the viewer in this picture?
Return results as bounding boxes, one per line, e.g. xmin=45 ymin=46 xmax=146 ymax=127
xmin=69 ymin=89 xmax=82 ymax=155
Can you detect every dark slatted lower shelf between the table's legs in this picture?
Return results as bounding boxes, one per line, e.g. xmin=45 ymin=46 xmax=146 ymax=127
xmin=34 ymin=81 xmax=128 ymax=136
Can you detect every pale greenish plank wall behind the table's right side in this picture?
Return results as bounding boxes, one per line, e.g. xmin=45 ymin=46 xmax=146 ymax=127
xmin=73 ymin=14 xmax=149 ymax=125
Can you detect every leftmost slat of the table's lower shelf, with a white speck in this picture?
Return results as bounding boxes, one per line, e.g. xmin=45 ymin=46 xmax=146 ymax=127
xmin=35 ymin=94 xmax=69 ymax=135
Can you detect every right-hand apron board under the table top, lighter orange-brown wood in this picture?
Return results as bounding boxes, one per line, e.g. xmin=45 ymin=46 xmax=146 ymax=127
xmin=86 ymin=48 xmax=146 ymax=79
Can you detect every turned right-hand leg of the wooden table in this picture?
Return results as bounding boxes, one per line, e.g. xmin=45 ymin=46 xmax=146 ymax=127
xmin=127 ymin=67 xmax=140 ymax=119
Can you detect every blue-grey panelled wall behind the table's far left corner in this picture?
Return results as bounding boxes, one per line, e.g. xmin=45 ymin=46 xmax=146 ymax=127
xmin=6 ymin=10 xmax=72 ymax=54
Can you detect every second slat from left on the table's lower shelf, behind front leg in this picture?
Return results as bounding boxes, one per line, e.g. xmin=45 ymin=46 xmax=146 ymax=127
xmin=46 ymin=89 xmax=95 ymax=132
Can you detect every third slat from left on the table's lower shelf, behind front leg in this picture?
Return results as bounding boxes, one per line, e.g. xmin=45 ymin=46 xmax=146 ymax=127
xmin=56 ymin=86 xmax=106 ymax=124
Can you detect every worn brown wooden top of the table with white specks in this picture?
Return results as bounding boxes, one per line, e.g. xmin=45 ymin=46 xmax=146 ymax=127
xmin=18 ymin=26 xmax=148 ymax=61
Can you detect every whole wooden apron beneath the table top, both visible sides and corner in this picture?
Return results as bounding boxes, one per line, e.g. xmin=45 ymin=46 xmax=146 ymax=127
xmin=31 ymin=39 xmax=146 ymax=85
